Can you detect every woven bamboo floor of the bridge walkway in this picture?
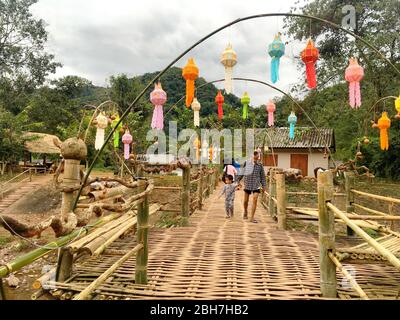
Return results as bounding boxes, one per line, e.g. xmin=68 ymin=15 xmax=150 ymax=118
xmin=48 ymin=184 xmax=400 ymax=300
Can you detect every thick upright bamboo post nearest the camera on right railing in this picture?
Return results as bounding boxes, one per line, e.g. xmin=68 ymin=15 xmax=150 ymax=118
xmin=318 ymin=171 xmax=337 ymax=298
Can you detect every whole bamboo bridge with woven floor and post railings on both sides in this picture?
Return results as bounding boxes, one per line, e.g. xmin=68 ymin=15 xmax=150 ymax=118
xmin=0 ymin=162 xmax=400 ymax=300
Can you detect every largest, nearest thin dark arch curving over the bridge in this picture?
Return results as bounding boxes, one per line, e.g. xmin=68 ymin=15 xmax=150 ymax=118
xmin=72 ymin=13 xmax=400 ymax=210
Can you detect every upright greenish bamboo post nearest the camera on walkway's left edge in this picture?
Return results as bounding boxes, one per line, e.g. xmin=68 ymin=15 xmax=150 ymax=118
xmin=135 ymin=195 xmax=149 ymax=284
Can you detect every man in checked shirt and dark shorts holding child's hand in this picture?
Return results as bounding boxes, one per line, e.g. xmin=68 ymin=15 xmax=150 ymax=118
xmin=238 ymin=151 xmax=266 ymax=223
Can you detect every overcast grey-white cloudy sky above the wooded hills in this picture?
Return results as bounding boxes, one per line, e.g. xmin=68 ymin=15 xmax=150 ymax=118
xmin=32 ymin=0 xmax=304 ymax=105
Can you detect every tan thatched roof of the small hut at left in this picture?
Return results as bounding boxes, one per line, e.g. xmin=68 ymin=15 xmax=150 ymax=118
xmin=23 ymin=132 xmax=61 ymax=153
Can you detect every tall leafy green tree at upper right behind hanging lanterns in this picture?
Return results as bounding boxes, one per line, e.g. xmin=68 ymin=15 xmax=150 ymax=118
xmin=277 ymin=0 xmax=400 ymax=177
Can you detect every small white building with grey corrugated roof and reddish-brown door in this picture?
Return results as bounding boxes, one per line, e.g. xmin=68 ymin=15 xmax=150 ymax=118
xmin=263 ymin=127 xmax=335 ymax=176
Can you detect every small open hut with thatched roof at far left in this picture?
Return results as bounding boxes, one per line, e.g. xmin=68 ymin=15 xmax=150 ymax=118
xmin=22 ymin=132 xmax=61 ymax=172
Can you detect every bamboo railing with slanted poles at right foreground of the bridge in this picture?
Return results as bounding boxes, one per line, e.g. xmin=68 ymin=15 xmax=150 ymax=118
xmin=318 ymin=171 xmax=400 ymax=299
